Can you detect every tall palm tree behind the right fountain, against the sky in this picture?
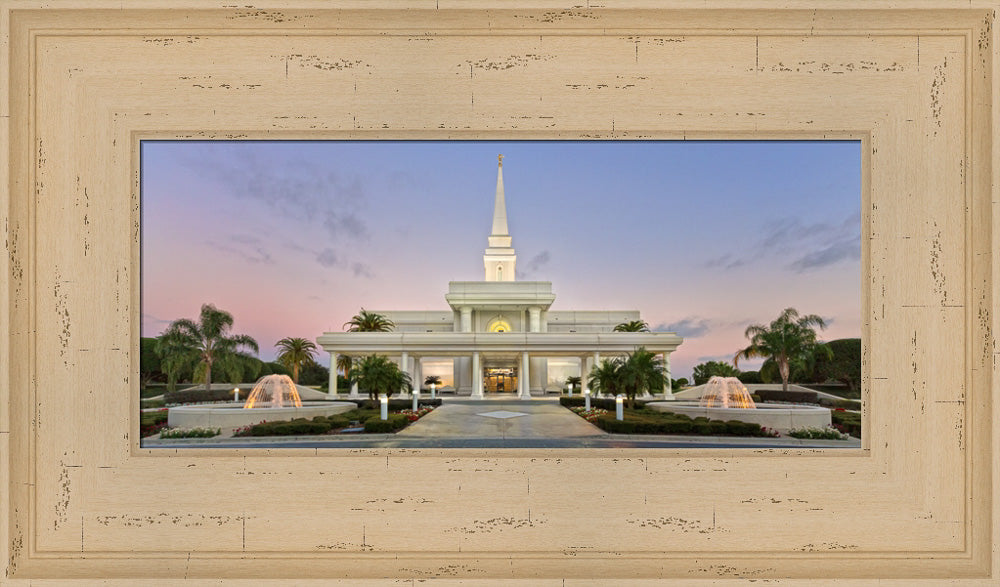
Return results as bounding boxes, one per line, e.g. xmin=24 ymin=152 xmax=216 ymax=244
xmin=733 ymin=308 xmax=832 ymax=391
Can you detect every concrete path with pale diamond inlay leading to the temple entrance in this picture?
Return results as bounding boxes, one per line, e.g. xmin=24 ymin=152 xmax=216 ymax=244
xmin=396 ymin=398 xmax=606 ymax=439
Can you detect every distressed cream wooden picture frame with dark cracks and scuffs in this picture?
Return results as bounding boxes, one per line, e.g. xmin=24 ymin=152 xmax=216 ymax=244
xmin=0 ymin=0 xmax=1000 ymax=585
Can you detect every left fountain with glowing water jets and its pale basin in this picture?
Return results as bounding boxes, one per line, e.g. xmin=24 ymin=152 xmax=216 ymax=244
xmin=167 ymin=375 xmax=358 ymax=432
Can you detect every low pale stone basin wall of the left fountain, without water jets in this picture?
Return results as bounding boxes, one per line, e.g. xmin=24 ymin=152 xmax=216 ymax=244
xmin=167 ymin=401 xmax=358 ymax=432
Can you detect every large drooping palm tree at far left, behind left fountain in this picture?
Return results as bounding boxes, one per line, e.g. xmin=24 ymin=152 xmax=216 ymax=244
xmin=158 ymin=304 xmax=260 ymax=391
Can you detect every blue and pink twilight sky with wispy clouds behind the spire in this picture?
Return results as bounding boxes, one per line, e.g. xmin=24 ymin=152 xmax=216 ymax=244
xmin=141 ymin=141 xmax=861 ymax=378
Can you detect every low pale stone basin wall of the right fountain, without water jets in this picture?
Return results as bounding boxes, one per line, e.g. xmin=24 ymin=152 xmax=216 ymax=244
xmin=646 ymin=401 xmax=831 ymax=431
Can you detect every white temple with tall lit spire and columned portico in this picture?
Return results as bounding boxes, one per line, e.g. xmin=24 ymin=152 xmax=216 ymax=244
xmin=317 ymin=155 xmax=683 ymax=399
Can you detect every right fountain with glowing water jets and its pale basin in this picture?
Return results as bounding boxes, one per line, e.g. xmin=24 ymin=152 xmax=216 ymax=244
xmin=646 ymin=376 xmax=830 ymax=430
